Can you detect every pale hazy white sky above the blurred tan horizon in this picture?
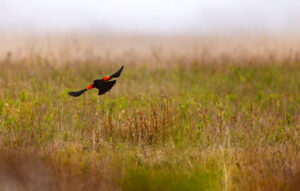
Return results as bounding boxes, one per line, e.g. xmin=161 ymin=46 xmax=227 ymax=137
xmin=0 ymin=0 xmax=300 ymax=33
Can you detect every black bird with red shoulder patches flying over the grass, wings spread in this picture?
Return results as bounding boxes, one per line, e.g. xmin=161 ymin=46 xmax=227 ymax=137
xmin=68 ymin=66 xmax=124 ymax=97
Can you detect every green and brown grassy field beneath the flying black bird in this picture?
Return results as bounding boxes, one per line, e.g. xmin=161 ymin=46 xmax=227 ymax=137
xmin=0 ymin=36 xmax=300 ymax=191
